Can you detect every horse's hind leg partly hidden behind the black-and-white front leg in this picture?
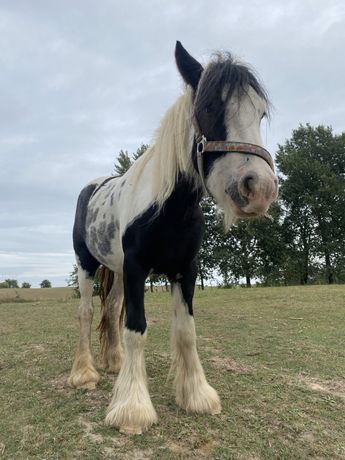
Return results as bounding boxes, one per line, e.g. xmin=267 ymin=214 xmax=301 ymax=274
xmin=99 ymin=273 xmax=123 ymax=373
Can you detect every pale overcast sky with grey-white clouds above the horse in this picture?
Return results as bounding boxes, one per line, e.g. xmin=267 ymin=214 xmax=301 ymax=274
xmin=0 ymin=0 xmax=345 ymax=287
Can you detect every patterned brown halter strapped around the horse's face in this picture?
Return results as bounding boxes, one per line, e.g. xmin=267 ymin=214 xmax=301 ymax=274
xmin=193 ymin=116 xmax=274 ymax=196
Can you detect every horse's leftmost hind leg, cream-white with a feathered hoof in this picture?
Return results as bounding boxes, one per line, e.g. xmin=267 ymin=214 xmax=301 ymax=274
xmin=68 ymin=265 xmax=99 ymax=390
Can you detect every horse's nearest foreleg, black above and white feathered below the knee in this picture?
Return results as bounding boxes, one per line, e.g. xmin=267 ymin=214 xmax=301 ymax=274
xmin=105 ymin=256 xmax=157 ymax=434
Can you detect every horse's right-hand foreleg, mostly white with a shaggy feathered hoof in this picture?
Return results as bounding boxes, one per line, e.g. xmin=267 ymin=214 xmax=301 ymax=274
xmin=171 ymin=266 xmax=221 ymax=414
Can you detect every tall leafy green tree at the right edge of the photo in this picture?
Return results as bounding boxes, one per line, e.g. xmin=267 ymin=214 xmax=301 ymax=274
xmin=277 ymin=125 xmax=345 ymax=284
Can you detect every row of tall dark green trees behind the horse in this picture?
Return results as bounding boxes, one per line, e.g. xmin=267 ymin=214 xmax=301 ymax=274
xmin=68 ymin=124 xmax=345 ymax=289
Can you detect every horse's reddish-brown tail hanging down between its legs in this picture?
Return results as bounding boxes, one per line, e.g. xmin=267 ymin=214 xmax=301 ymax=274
xmin=97 ymin=265 xmax=124 ymax=354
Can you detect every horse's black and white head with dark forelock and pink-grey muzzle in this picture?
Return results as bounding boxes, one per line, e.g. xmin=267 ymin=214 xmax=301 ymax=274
xmin=175 ymin=42 xmax=278 ymax=226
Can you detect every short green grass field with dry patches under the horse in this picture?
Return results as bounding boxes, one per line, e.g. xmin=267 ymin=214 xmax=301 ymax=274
xmin=0 ymin=286 xmax=345 ymax=460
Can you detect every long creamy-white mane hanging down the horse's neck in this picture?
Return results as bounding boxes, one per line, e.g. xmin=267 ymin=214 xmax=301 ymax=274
xmin=130 ymin=88 xmax=198 ymax=209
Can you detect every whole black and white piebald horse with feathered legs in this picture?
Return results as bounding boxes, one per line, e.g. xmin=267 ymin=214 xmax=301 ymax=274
xmin=68 ymin=41 xmax=278 ymax=434
